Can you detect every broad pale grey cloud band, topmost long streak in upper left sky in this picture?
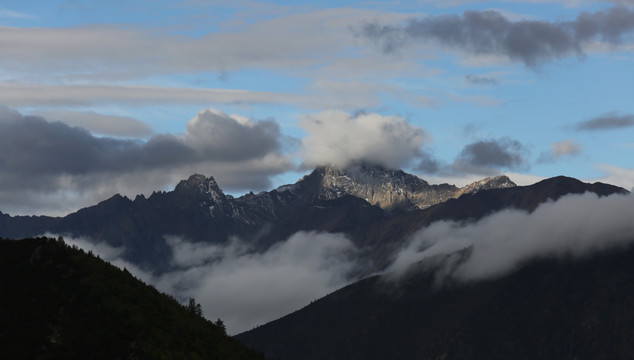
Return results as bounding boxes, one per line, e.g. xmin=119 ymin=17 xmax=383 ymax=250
xmin=0 ymin=5 xmax=405 ymax=80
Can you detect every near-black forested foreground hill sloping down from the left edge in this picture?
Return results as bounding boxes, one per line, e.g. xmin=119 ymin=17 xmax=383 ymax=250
xmin=0 ymin=238 xmax=263 ymax=359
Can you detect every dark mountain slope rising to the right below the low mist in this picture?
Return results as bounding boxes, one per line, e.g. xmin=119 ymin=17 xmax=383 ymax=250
xmin=237 ymin=242 xmax=634 ymax=360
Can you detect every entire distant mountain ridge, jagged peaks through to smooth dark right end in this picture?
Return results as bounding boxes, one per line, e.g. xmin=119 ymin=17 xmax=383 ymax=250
xmin=0 ymin=165 xmax=626 ymax=273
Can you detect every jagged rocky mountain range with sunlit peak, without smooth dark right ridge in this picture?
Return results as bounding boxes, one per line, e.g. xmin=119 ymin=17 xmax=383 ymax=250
xmin=0 ymin=165 xmax=515 ymax=271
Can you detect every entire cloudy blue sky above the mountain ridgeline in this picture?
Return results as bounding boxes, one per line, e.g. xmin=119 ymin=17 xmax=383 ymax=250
xmin=0 ymin=0 xmax=634 ymax=215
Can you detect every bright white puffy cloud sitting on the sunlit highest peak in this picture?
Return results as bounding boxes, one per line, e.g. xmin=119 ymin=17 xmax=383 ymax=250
xmin=299 ymin=111 xmax=429 ymax=168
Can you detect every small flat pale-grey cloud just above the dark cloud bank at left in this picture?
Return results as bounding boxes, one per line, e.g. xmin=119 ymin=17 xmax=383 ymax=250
xmin=33 ymin=110 xmax=154 ymax=137
